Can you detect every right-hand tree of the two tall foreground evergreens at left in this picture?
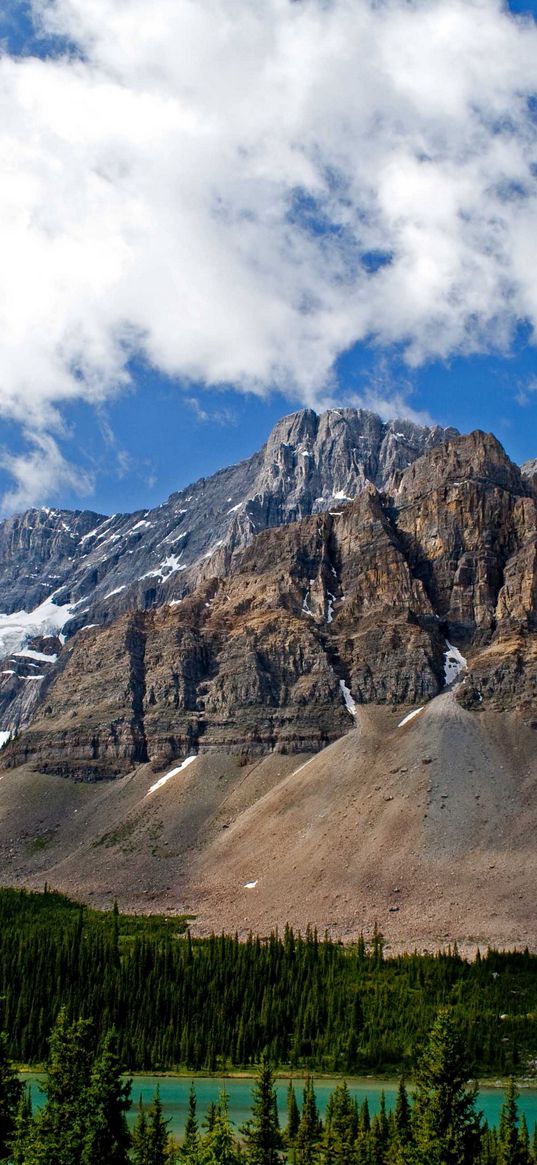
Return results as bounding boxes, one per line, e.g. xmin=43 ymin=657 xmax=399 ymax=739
xmin=80 ymin=1032 xmax=130 ymax=1165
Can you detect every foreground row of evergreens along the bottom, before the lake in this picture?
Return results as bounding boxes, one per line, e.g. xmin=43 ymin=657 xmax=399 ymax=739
xmin=0 ymin=1011 xmax=537 ymax=1165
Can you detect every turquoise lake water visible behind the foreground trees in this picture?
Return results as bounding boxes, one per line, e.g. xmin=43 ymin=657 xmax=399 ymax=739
xmin=24 ymin=1073 xmax=537 ymax=1137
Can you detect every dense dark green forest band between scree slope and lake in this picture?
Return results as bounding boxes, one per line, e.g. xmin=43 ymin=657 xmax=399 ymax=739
xmin=0 ymin=890 xmax=537 ymax=1075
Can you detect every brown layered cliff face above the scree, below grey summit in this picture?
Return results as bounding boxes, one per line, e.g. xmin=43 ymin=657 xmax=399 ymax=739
xmin=2 ymin=426 xmax=537 ymax=779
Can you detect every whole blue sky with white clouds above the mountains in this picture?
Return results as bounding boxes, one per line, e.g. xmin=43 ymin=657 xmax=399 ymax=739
xmin=0 ymin=0 xmax=537 ymax=513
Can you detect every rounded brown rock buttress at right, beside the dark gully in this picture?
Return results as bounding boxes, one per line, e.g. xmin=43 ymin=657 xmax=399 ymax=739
xmin=394 ymin=432 xmax=526 ymax=638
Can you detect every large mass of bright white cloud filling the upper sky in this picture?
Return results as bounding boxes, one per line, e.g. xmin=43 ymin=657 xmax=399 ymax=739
xmin=0 ymin=0 xmax=537 ymax=503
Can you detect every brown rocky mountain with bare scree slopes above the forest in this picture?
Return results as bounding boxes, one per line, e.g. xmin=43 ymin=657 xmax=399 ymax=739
xmin=0 ymin=412 xmax=537 ymax=946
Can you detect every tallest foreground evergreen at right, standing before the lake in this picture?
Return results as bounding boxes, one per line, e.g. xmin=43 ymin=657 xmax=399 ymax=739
xmin=411 ymin=1011 xmax=481 ymax=1165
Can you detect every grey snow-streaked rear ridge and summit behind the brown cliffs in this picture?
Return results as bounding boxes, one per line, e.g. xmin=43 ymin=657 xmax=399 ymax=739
xmin=0 ymin=409 xmax=455 ymax=633
